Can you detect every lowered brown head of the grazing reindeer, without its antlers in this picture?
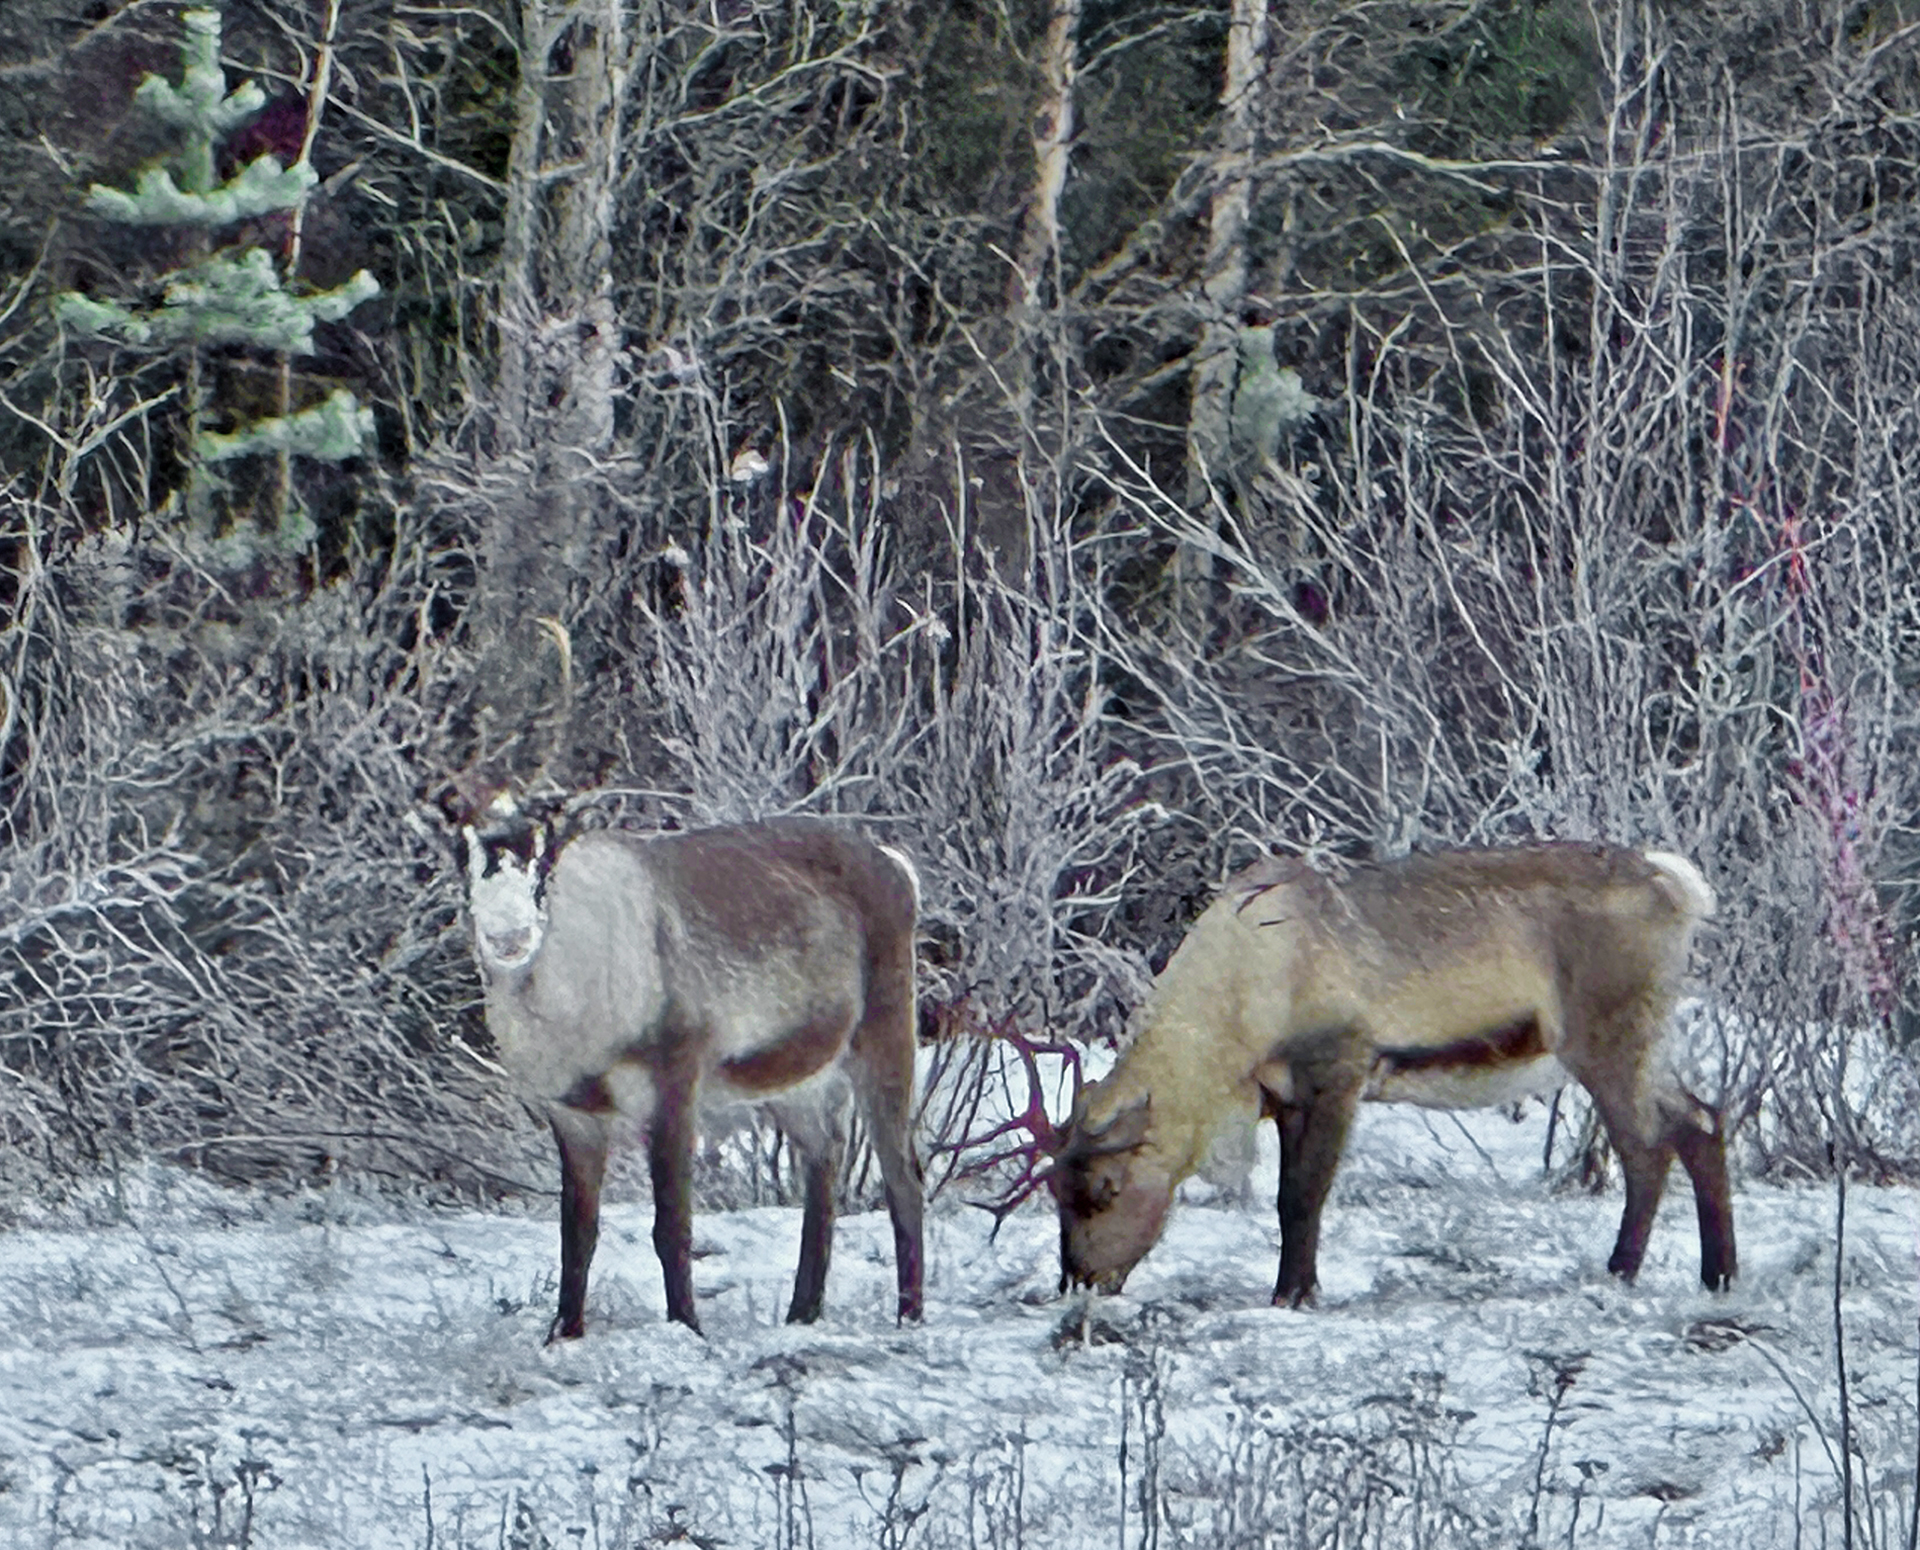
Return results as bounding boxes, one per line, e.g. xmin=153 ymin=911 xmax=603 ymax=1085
xmin=1046 ymin=1097 xmax=1173 ymax=1293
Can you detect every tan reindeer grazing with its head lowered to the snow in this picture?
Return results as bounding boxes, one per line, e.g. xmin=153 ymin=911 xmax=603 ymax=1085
xmin=1050 ymin=845 xmax=1736 ymax=1306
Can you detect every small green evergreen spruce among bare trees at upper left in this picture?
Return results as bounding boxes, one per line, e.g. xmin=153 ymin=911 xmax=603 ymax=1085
xmin=56 ymin=10 xmax=380 ymax=565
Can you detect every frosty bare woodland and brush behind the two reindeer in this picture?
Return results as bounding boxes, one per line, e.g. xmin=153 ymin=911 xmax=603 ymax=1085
xmin=0 ymin=0 xmax=1920 ymax=1195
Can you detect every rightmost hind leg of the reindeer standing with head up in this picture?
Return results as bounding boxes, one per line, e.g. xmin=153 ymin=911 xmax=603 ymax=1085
xmin=852 ymin=933 xmax=925 ymax=1323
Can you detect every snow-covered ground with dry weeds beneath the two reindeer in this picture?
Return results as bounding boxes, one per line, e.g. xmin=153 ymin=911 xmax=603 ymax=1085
xmin=0 ymin=1108 xmax=1920 ymax=1550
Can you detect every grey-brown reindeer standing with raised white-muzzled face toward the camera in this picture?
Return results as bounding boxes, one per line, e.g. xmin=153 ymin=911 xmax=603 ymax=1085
xmin=463 ymin=818 xmax=922 ymax=1343
